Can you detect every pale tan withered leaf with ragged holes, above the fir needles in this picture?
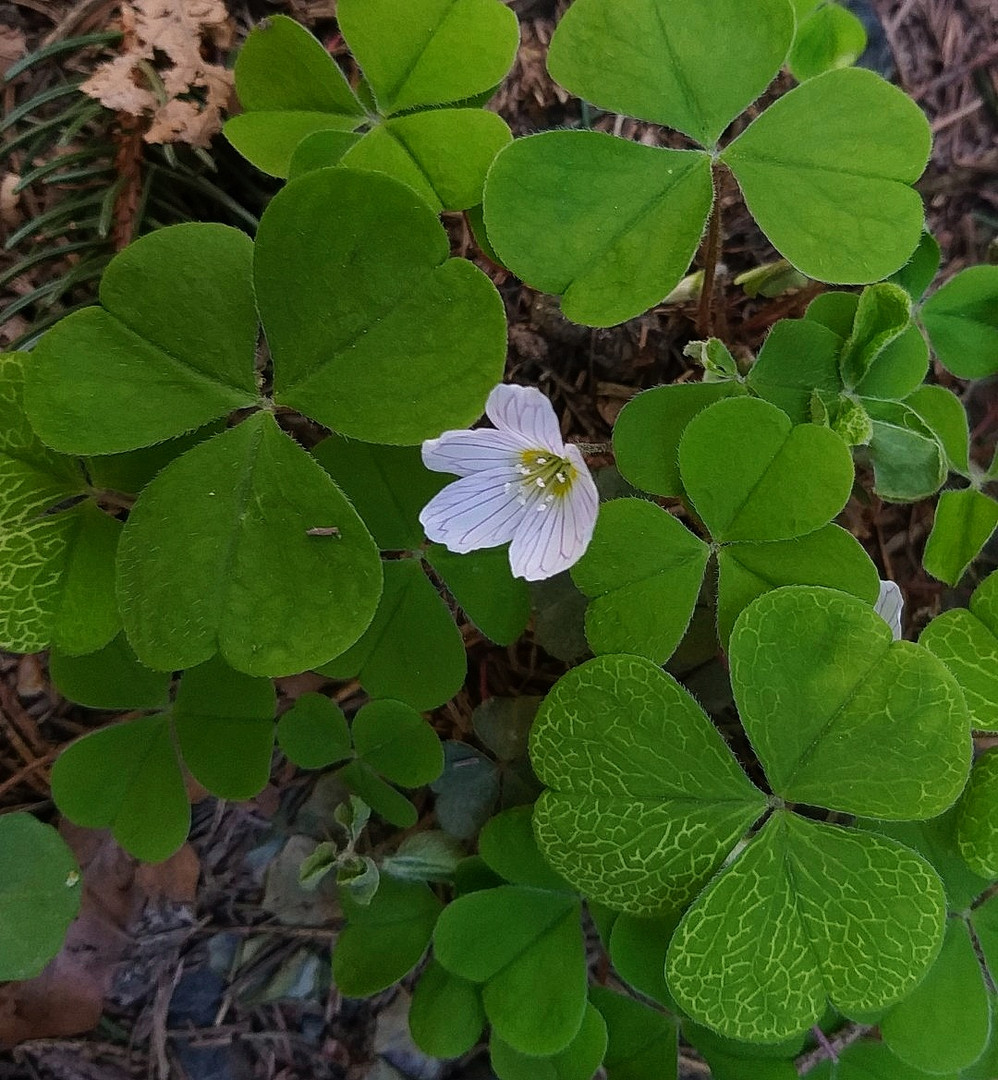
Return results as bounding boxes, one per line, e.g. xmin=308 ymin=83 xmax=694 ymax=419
xmin=82 ymin=0 xmax=234 ymax=147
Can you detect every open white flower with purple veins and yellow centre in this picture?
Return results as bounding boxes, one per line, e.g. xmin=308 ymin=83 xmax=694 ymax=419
xmin=419 ymin=386 xmax=599 ymax=581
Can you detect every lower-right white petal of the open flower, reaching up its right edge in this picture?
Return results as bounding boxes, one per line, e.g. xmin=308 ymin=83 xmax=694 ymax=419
xmin=510 ymin=446 xmax=599 ymax=581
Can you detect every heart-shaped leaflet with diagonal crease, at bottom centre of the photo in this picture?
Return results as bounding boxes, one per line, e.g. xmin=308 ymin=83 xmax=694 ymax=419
xmin=433 ymin=885 xmax=588 ymax=1056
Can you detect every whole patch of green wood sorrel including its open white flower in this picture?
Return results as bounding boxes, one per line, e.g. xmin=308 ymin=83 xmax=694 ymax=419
xmin=0 ymin=0 xmax=998 ymax=1080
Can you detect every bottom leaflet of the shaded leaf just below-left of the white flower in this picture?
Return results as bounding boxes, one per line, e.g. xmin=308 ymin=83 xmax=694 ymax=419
xmin=319 ymin=558 xmax=467 ymax=710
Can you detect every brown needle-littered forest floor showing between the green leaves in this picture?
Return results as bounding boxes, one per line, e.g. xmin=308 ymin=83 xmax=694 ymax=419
xmin=0 ymin=0 xmax=998 ymax=1080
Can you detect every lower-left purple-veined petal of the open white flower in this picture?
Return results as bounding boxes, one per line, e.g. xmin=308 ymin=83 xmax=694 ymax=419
xmin=419 ymin=469 xmax=525 ymax=554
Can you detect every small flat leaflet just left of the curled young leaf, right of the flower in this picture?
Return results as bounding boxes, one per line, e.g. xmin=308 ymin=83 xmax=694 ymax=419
xmin=746 ymin=319 xmax=842 ymax=423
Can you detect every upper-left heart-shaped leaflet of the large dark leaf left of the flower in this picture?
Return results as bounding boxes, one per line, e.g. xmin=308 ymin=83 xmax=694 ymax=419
xmin=25 ymin=222 xmax=258 ymax=454
